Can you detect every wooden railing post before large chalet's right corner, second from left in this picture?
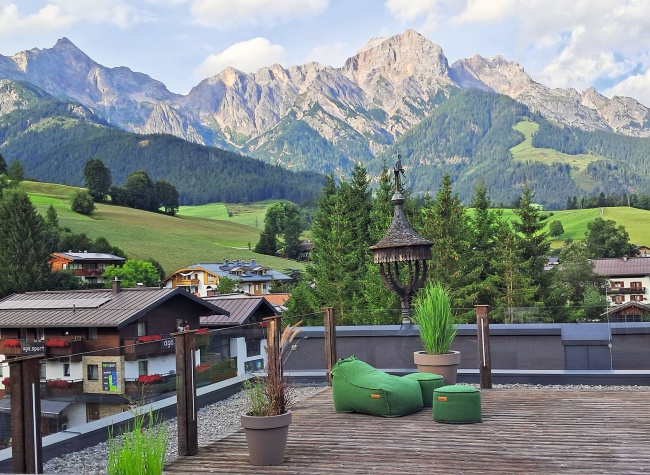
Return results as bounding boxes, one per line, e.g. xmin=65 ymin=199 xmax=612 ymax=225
xmin=172 ymin=330 xmax=199 ymax=455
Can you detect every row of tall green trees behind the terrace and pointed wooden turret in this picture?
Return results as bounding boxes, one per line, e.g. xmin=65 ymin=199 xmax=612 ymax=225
xmin=288 ymin=165 xmax=635 ymax=325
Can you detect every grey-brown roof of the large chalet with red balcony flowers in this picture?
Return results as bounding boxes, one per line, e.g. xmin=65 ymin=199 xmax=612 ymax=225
xmin=0 ymin=288 xmax=228 ymax=328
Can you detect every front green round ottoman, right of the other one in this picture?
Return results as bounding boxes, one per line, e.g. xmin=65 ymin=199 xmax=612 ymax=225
xmin=433 ymin=384 xmax=481 ymax=424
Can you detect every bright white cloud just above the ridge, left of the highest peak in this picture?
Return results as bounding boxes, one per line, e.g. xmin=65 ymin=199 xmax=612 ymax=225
xmin=194 ymin=38 xmax=286 ymax=79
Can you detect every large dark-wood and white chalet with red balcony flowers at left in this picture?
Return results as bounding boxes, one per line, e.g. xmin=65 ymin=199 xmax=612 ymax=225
xmin=0 ymin=281 xmax=228 ymax=438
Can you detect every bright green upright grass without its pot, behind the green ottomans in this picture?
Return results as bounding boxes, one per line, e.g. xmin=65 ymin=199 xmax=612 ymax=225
xmin=412 ymin=281 xmax=456 ymax=355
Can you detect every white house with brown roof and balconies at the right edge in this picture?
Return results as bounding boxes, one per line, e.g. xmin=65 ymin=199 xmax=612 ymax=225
xmin=593 ymin=257 xmax=650 ymax=305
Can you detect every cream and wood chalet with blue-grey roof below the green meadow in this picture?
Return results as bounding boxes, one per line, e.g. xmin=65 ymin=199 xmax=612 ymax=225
xmin=164 ymin=259 xmax=291 ymax=297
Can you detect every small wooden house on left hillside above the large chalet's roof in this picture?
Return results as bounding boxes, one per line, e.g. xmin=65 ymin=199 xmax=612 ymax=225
xmin=48 ymin=251 xmax=126 ymax=284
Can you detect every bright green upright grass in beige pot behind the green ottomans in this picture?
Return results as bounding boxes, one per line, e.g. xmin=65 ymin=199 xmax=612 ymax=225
xmin=413 ymin=281 xmax=460 ymax=385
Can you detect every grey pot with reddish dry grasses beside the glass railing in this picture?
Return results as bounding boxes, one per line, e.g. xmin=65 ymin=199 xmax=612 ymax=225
xmin=241 ymin=322 xmax=302 ymax=465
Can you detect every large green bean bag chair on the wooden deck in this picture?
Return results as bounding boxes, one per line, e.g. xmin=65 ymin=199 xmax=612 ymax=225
xmin=332 ymin=355 xmax=423 ymax=417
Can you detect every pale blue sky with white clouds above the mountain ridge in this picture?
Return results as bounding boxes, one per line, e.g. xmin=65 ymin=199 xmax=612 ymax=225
xmin=0 ymin=0 xmax=650 ymax=107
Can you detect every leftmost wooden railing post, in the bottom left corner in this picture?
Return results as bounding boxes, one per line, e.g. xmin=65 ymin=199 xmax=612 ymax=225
xmin=9 ymin=355 xmax=43 ymax=473
